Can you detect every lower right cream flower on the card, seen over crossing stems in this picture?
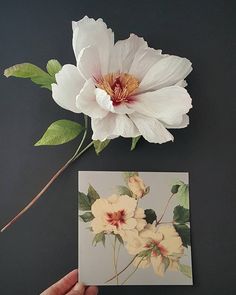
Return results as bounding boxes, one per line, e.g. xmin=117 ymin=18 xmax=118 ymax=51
xmin=126 ymin=224 xmax=184 ymax=276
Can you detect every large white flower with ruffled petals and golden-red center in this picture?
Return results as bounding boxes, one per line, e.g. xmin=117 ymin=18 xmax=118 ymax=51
xmin=52 ymin=16 xmax=192 ymax=143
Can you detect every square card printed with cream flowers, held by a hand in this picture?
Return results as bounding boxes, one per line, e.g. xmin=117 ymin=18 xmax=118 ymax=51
xmin=79 ymin=171 xmax=193 ymax=285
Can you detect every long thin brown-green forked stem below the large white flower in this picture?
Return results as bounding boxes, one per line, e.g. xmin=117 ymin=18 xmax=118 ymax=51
xmin=1 ymin=116 xmax=93 ymax=232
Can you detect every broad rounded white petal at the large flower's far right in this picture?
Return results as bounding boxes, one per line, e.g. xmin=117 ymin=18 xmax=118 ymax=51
xmin=132 ymin=86 xmax=192 ymax=125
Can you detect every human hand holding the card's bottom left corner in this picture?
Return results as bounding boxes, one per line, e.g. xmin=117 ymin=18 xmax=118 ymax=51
xmin=40 ymin=269 xmax=98 ymax=295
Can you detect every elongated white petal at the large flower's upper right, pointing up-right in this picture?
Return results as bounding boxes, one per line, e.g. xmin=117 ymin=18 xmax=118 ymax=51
xmin=139 ymin=55 xmax=192 ymax=92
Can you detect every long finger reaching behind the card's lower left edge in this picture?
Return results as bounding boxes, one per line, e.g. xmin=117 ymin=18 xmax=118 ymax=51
xmin=41 ymin=269 xmax=78 ymax=295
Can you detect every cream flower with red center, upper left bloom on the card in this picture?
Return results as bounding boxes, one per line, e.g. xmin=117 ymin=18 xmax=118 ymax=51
xmin=91 ymin=195 xmax=146 ymax=239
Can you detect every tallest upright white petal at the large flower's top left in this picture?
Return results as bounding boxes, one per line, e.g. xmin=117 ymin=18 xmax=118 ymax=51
xmin=72 ymin=16 xmax=114 ymax=74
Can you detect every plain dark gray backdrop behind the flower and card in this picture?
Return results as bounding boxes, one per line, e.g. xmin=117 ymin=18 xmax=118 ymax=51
xmin=0 ymin=0 xmax=236 ymax=295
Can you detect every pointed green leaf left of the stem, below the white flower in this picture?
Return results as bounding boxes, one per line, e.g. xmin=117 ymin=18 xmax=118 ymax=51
xmin=35 ymin=120 xmax=84 ymax=146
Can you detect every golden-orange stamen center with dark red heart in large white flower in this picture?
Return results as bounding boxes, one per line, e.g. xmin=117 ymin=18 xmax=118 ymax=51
xmin=96 ymin=73 xmax=139 ymax=106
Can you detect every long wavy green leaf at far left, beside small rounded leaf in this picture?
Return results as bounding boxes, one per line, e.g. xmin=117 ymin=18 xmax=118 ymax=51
xmin=4 ymin=63 xmax=56 ymax=90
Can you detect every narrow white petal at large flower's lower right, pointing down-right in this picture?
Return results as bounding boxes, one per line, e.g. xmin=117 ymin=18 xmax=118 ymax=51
xmin=129 ymin=113 xmax=174 ymax=143
